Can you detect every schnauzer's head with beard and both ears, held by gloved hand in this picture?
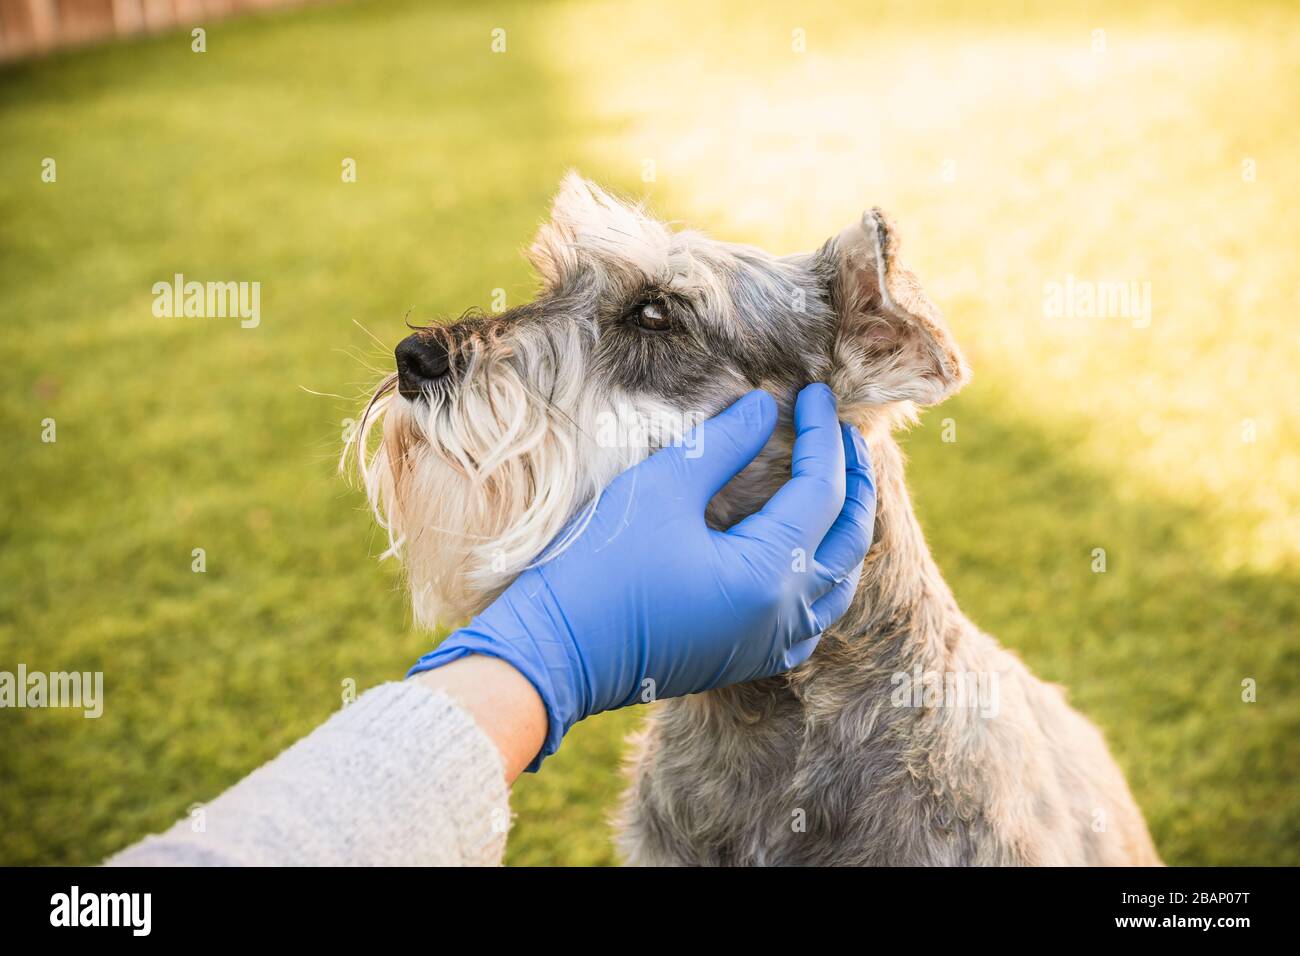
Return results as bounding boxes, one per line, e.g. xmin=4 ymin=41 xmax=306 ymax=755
xmin=354 ymin=174 xmax=967 ymax=624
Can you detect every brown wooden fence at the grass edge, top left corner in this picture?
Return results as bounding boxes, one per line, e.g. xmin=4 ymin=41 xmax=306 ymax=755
xmin=0 ymin=0 xmax=319 ymax=60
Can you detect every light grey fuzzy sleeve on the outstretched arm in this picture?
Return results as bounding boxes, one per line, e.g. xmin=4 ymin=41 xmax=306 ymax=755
xmin=107 ymin=682 xmax=510 ymax=866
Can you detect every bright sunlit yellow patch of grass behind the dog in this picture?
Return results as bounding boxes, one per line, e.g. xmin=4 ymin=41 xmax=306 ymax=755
xmin=553 ymin=4 xmax=1300 ymax=568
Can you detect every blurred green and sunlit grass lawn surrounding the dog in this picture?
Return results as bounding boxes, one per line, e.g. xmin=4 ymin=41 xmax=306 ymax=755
xmin=0 ymin=0 xmax=1300 ymax=865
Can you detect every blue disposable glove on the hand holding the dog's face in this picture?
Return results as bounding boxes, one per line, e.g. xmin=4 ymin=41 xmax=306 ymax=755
xmin=408 ymin=385 xmax=876 ymax=770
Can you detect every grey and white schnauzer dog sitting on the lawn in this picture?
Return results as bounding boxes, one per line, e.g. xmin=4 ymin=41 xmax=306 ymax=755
xmin=354 ymin=173 xmax=1160 ymax=865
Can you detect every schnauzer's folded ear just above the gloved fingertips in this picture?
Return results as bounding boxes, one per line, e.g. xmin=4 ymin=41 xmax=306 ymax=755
xmin=816 ymin=209 xmax=970 ymax=405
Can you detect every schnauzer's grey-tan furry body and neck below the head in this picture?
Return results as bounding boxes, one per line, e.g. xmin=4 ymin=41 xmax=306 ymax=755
xmin=619 ymin=436 xmax=1160 ymax=865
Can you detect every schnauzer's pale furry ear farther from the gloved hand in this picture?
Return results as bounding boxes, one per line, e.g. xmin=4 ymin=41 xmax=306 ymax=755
xmin=528 ymin=172 xmax=670 ymax=289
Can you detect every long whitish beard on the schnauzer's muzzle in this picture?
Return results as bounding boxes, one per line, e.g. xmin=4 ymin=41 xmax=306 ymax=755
xmin=351 ymin=329 xmax=662 ymax=627
